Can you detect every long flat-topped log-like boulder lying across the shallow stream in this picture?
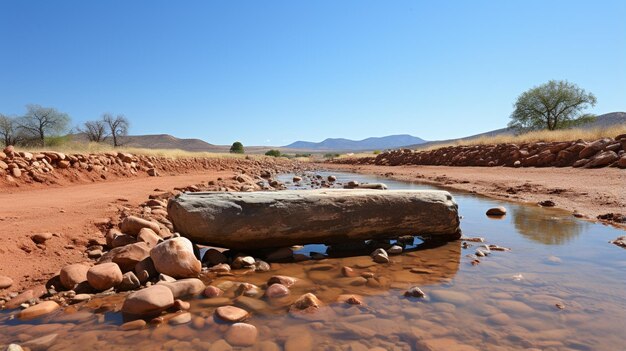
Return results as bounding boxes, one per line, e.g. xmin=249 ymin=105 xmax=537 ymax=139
xmin=167 ymin=189 xmax=461 ymax=249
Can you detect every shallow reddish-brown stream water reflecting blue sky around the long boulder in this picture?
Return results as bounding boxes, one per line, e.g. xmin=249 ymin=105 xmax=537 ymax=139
xmin=0 ymin=174 xmax=626 ymax=351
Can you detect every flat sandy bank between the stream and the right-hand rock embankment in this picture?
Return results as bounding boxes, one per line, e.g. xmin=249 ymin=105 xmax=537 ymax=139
xmin=320 ymin=164 xmax=626 ymax=228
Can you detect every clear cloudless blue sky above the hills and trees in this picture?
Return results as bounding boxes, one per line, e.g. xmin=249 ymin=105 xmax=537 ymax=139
xmin=0 ymin=0 xmax=626 ymax=145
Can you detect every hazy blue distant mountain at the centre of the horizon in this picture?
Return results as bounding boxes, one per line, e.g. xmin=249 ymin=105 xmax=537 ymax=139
xmin=283 ymin=134 xmax=426 ymax=151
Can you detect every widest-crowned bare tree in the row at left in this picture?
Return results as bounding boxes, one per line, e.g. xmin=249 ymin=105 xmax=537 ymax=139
xmin=18 ymin=105 xmax=70 ymax=146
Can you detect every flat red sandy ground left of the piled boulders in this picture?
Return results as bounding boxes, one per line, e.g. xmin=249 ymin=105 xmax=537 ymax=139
xmin=0 ymin=171 xmax=233 ymax=291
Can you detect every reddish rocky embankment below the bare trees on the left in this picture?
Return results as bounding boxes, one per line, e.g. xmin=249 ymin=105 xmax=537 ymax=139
xmin=0 ymin=146 xmax=302 ymax=190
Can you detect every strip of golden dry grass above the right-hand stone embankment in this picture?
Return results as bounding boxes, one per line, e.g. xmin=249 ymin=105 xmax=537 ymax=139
xmin=417 ymin=125 xmax=626 ymax=151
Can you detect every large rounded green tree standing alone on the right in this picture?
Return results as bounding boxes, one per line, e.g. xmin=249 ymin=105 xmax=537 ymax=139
xmin=509 ymin=80 xmax=596 ymax=131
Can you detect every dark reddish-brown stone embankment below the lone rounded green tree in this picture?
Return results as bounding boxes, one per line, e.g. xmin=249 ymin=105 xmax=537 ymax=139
xmin=331 ymin=135 xmax=626 ymax=168
